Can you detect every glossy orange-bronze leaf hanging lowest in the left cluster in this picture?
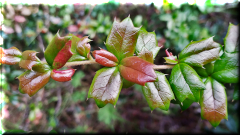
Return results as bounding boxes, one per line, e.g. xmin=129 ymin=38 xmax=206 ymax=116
xmin=18 ymin=70 xmax=51 ymax=97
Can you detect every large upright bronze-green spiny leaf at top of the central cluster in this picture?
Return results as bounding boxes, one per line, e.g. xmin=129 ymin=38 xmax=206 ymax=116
xmin=106 ymin=17 xmax=140 ymax=61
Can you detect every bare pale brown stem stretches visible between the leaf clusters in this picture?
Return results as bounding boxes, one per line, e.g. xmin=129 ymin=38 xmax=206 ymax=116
xmin=59 ymin=59 xmax=175 ymax=70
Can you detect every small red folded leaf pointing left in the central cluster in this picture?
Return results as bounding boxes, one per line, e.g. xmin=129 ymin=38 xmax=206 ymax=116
xmin=93 ymin=49 xmax=118 ymax=67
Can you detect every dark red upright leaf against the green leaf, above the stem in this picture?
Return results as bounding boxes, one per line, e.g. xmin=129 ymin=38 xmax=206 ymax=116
xmin=53 ymin=40 xmax=73 ymax=69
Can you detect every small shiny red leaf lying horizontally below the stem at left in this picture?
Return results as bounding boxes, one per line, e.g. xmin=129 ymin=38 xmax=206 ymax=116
xmin=51 ymin=69 xmax=75 ymax=82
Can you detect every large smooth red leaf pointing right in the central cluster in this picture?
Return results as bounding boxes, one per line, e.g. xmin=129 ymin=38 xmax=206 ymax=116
xmin=119 ymin=56 xmax=157 ymax=86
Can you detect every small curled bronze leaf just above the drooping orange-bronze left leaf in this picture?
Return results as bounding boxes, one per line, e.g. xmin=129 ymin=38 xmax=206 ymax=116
xmin=19 ymin=50 xmax=41 ymax=70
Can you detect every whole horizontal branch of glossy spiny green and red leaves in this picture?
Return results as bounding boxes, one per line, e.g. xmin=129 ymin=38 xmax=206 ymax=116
xmin=0 ymin=17 xmax=239 ymax=127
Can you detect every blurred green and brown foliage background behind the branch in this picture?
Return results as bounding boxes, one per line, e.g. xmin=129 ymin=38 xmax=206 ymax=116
xmin=0 ymin=0 xmax=239 ymax=133
